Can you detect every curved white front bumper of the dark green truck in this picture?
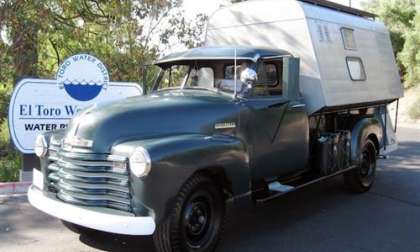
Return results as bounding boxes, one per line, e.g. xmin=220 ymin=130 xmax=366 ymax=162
xmin=28 ymin=185 xmax=156 ymax=235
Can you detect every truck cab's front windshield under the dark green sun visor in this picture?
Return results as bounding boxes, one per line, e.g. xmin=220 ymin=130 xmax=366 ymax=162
xmin=155 ymin=61 xmax=252 ymax=93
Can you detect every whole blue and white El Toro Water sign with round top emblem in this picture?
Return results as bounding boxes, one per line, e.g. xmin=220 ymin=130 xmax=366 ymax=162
xmin=9 ymin=54 xmax=143 ymax=154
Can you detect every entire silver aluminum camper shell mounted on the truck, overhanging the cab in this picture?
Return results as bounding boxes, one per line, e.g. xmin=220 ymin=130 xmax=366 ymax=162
xmin=204 ymin=0 xmax=403 ymax=114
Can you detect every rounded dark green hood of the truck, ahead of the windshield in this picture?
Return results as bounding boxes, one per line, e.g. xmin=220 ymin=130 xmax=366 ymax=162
xmin=65 ymin=90 xmax=239 ymax=153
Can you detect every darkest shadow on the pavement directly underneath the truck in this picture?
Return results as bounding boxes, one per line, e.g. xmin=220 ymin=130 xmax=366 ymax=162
xmin=79 ymin=177 xmax=353 ymax=252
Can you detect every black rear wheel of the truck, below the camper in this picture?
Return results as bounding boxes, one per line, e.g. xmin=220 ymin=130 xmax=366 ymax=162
xmin=344 ymin=139 xmax=376 ymax=193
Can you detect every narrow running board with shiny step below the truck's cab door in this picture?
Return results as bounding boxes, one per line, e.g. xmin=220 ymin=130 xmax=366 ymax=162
xmin=256 ymin=165 xmax=357 ymax=203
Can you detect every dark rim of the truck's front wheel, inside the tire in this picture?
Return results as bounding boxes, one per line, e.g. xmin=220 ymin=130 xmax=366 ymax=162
xmin=182 ymin=191 xmax=215 ymax=248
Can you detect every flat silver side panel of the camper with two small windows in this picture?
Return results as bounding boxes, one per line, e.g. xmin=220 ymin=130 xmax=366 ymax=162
xmin=305 ymin=3 xmax=403 ymax=107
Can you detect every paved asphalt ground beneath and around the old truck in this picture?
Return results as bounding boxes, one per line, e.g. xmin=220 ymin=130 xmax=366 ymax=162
xmin=0 ymin=129 xmax=420 ymax=252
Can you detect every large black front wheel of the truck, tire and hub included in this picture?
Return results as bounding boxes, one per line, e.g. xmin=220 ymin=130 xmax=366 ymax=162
xmin=153 ymin=174 xmax=225 ymax=252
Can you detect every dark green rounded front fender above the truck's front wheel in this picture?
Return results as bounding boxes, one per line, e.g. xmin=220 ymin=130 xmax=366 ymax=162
xmin=113 ymin=134 xmax=250 ymax=222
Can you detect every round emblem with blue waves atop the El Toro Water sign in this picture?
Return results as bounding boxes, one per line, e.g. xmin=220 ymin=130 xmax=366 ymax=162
xmin=56 ymin=54 xmax=109 ymax=101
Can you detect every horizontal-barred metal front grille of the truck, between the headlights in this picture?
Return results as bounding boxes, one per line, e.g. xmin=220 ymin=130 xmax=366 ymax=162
xmin=47 ymin=149 xmax=132 ymax=212
